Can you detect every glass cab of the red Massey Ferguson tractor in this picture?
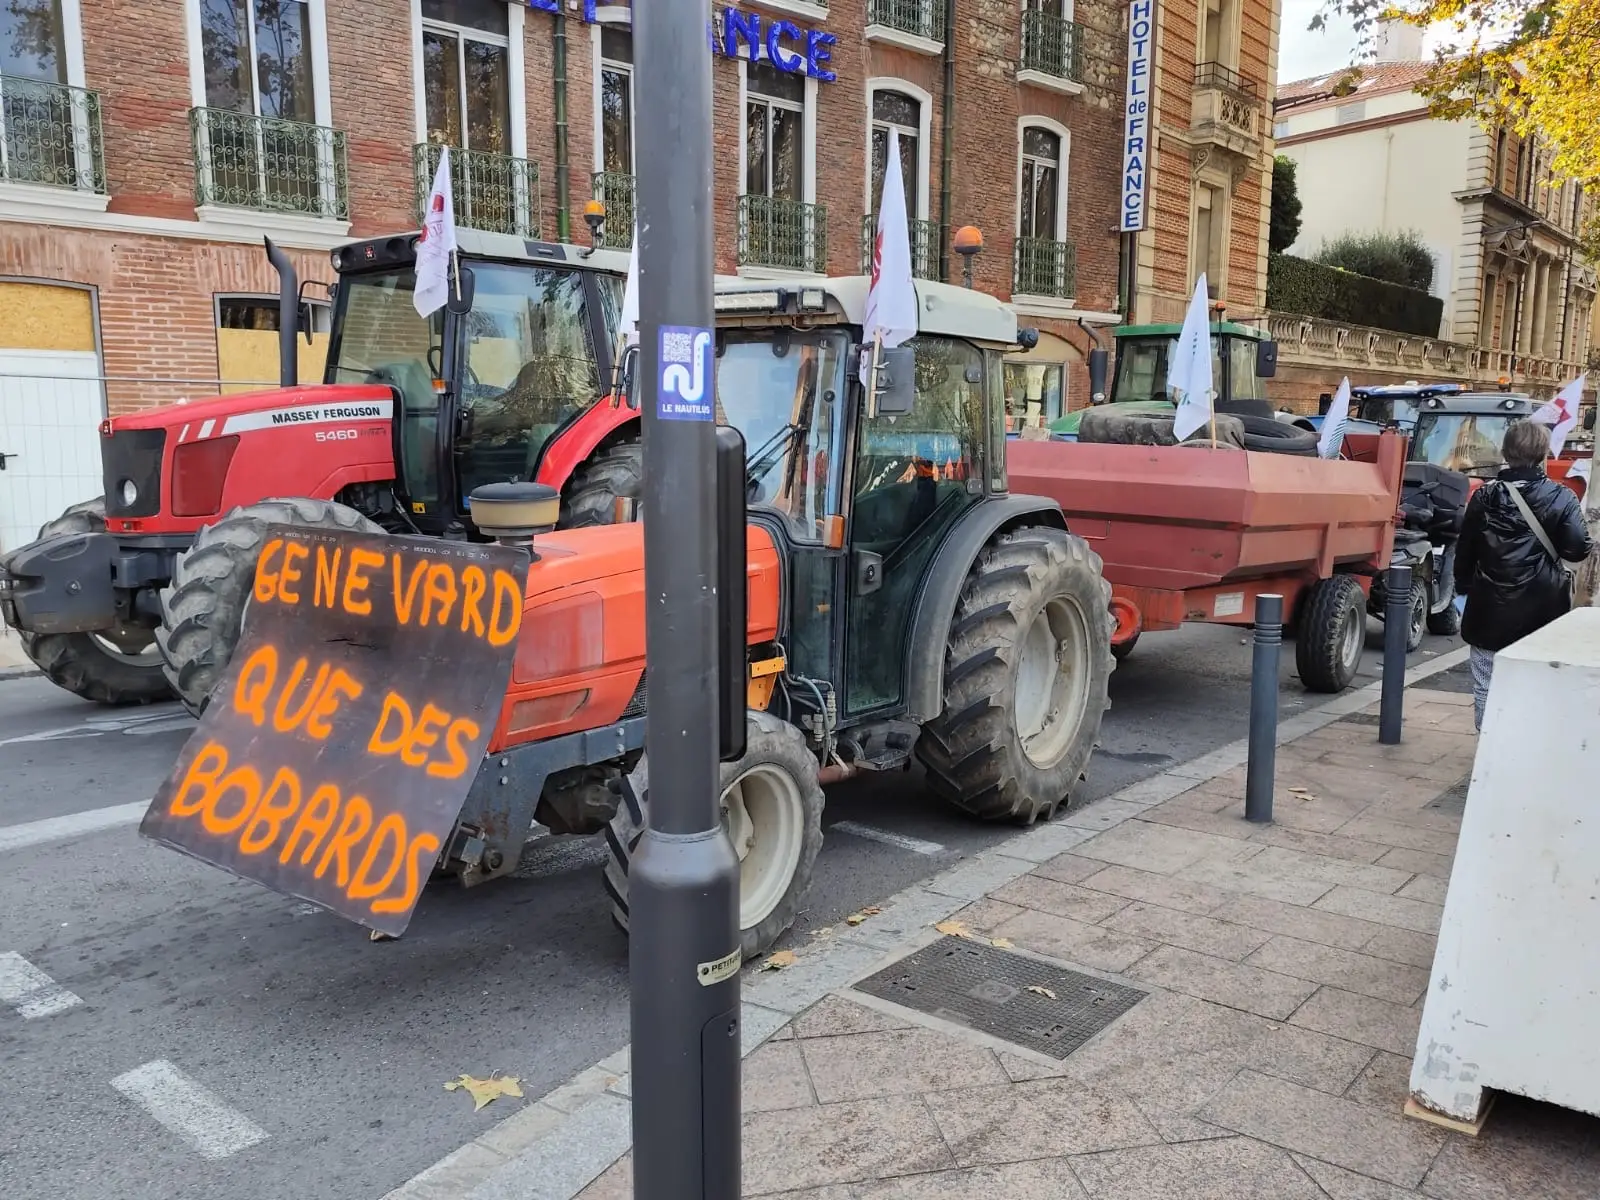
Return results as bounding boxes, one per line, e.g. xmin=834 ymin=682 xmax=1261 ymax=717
xmin=325 ymin=229 xmax=634 ymax=533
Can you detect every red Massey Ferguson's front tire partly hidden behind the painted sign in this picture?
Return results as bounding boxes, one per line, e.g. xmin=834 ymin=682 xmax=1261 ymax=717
xmin=155 ymin=499 xmax=382 ymax=717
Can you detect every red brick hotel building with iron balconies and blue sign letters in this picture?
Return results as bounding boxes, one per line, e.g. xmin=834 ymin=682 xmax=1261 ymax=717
xmin=0 ymin=0 xmax=1145 ymax=432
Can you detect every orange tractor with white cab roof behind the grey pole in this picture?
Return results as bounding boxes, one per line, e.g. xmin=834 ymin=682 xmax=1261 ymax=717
xmin=140 ymin=277 xmax=1112 ymax=958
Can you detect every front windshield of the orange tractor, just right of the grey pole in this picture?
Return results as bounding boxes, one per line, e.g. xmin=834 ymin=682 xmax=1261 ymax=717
xmin=717 ymin=330 xmax=850 ymax=541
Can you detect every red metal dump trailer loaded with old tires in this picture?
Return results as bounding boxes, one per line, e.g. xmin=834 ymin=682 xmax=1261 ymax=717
xmin=1006 ymin=430 xmax=1405 ymax=691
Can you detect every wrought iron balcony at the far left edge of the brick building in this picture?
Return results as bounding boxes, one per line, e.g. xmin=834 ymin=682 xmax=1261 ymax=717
xmin=0 ymin=75 xmax=106 ymax=195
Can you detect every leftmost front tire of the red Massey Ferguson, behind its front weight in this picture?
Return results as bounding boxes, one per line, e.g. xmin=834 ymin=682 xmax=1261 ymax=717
xmin=18 ymin=498 xmax=173 ymax=706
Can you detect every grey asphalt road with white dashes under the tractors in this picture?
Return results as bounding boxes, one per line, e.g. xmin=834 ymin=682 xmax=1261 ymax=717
xmin=0 ymin=624 xmax=1459 ymax=1200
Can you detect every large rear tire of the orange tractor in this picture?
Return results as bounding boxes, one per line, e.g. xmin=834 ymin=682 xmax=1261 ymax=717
xmin=917 ymin=526 xmax=1114 ymax=824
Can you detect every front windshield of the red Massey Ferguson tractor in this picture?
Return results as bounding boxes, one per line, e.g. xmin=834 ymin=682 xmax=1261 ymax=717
xmin=326 ymin=270 xmax=445 ymax=507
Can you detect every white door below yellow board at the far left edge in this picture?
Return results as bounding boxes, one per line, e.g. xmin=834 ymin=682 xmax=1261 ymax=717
xmin=0 ymin=349 xmax=106 ymax=554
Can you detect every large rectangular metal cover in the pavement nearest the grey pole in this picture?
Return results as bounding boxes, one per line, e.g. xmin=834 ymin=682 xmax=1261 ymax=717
xmin=856 ymin=938 xmax=1146 ymax=1059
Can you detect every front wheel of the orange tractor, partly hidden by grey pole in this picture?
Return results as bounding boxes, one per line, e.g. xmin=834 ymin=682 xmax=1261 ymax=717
xmin=605 ymin=712 xmax=822 ymax=962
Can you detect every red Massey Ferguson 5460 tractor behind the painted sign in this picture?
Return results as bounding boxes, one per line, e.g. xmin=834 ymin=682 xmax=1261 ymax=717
xmin=0 ymin=229 xmax=642 ymax=712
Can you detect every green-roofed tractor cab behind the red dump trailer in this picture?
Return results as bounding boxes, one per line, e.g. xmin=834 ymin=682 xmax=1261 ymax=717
xmin=1050 ymin=320 xmax=1278 ymax=440
